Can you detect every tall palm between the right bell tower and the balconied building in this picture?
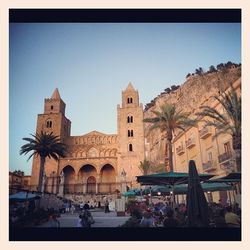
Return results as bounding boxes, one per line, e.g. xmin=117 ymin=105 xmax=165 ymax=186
xmin=143 ymin=104 xmax=196 ymax=171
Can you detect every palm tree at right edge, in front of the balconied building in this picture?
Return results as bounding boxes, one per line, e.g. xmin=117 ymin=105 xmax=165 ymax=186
xmin=197 ymin=84 xmax=241 ymax=172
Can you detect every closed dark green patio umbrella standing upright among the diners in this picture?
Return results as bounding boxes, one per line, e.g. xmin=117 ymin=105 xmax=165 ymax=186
xmin=187 ymin=160 xmax=208 ymax=227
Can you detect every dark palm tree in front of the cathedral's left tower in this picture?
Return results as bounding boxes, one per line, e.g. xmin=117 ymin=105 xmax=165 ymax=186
xmin=20 ymin=132 xmax=66 ymax=192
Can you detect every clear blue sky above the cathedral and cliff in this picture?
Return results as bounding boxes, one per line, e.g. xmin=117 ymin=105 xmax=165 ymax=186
xmin=9 ymin=23 xmax=241 ymax=174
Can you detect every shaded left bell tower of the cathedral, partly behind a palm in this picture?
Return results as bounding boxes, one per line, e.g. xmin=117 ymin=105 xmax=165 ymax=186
xmin=31 ymin=88 xmax=71 ymax=186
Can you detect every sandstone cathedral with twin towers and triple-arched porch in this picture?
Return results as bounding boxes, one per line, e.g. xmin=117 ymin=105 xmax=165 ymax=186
xmin=31 ymin=83 xmax=145 ymax=196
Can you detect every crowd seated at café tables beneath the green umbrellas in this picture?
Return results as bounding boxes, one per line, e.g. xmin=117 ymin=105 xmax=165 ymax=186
xmin=123 ymin=198 xmax=241 ymax=228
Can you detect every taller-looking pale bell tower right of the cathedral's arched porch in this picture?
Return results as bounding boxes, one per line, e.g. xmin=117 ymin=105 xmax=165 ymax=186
xmin=117 ymin=83 xmax=144 ymax=186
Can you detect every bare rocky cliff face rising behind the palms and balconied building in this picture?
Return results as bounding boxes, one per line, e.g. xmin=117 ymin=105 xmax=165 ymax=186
xmin=144 ymin=67 xmax=241 ymax=168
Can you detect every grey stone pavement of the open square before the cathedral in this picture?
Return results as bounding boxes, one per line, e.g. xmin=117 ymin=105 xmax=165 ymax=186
xmin=39 ymin=210 xmax=130 ymax=227
